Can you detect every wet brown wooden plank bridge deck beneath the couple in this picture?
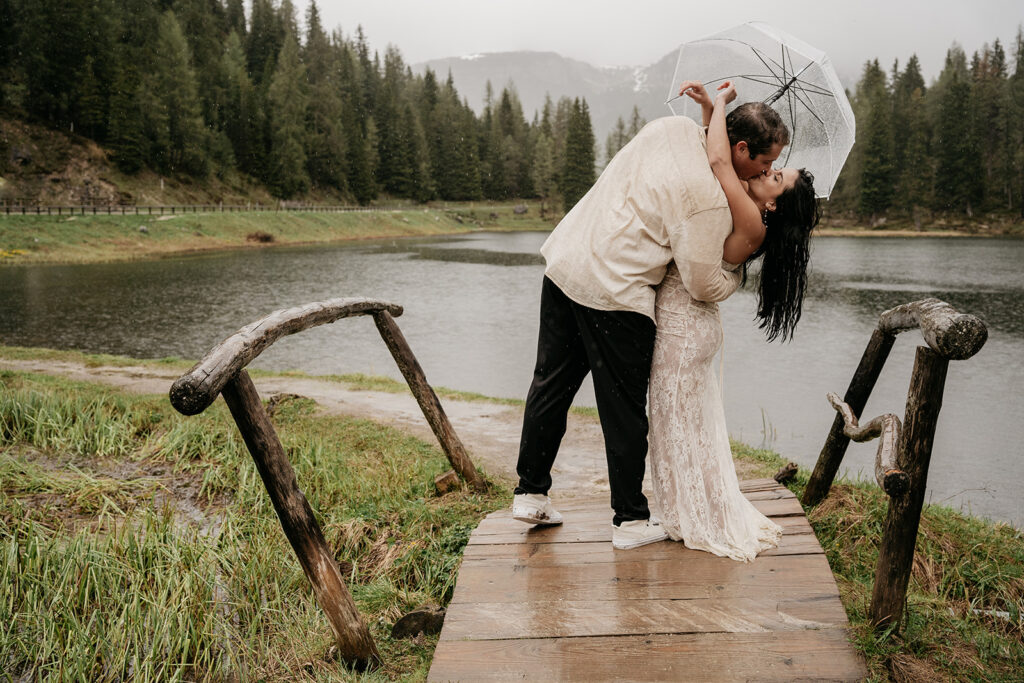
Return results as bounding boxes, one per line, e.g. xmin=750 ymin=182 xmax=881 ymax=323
xmin=429 ymin=479 xmax=867 ymax=681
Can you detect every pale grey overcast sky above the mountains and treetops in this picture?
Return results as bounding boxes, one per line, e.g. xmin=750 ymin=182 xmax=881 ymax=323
xmin=293 ymin=0 xmax=1024 ymax=80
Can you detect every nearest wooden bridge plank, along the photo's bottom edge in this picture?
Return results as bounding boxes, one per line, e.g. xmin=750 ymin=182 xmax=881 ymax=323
xmin=428 ymin=629 xmax=867 ymax=681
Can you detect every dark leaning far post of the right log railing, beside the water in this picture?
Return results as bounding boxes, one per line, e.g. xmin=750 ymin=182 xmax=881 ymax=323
xmin=800 ymin=328 xmax=896 ymax=506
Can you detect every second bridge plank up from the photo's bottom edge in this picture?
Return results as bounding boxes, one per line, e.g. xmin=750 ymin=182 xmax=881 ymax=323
xmin=441 ymin=595 xmax=848 ymax=640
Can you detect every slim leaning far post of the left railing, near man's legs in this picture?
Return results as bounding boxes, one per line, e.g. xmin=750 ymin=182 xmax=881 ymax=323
xmin=373 ymin=309 xmax=487 ymax=492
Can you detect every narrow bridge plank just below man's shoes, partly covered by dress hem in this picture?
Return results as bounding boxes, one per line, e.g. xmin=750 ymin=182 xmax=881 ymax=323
xmin=462 ymin=532 xmax=824 ymax=567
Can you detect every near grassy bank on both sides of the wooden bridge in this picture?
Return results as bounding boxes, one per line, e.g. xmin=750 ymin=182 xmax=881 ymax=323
xmin=0 ymin=347 xmax=1024 ymax=681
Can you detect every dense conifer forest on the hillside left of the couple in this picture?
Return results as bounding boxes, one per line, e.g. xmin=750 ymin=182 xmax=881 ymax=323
xmin=0 ymin=0 xmax=595 ymax=204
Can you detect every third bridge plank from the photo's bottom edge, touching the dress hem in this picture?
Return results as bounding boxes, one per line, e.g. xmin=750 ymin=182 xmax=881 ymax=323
xmin=452 ymin=544 xmax=838 ymax=602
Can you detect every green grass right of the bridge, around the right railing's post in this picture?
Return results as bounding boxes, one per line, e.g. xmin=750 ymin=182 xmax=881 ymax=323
xmin=733 ymin=442 xmax=1024 ymax=682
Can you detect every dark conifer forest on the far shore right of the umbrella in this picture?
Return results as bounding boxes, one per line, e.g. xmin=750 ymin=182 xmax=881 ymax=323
xmin=829 ymin=34 xmax=1024 ymax=220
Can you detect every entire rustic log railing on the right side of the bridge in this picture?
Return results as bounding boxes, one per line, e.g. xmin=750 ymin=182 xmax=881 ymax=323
xmin=801 ymin=299 xmax=988 ymax=628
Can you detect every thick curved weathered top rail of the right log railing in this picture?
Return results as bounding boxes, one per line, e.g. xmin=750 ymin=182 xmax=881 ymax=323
xmin=878 ymin=299 xmax=988 ymax=360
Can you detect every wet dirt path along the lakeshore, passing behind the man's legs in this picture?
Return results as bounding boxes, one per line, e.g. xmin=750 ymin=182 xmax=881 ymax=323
xmin=0 ymin=358 xmax=761 ymax=499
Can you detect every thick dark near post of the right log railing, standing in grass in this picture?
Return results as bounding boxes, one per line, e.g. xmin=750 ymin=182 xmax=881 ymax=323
xmin=868 ymin=346 xmax=949 ymax=628
